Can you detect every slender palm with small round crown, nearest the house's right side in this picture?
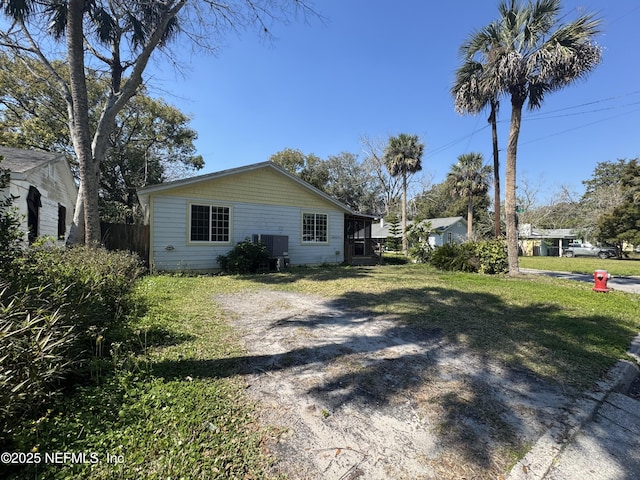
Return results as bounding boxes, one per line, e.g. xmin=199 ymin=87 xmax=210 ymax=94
xmin=384 ymin=133 xmax=424 ymax=252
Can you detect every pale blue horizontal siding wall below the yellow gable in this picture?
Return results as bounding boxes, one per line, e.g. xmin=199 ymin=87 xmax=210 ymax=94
xmin=151 ymin=196 xmax=344 ymax=270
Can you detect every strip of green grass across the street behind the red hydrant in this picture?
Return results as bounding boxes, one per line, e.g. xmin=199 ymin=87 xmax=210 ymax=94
xmin=520 ymin=257 xmax=640 ymax=276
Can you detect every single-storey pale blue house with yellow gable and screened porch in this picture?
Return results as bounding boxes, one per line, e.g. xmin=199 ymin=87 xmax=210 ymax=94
xmin=138 ymin=162 xmax=377 ymax=271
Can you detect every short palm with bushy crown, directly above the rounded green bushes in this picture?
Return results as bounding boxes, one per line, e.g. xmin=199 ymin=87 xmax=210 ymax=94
xmin=447 ymin=153 xmax=491 ymax=240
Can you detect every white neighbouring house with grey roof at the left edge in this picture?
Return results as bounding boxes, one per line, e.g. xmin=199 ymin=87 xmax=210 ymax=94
xmin=0 ymin=147 xmax=78 ymax=243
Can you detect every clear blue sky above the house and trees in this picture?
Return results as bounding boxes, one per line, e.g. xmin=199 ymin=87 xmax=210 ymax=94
xmin=146 ymin=0 xmax=640 ymax=203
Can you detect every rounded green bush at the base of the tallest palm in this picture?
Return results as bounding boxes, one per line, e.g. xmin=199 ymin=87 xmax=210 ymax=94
xmin=429 ymin=240 xmax=508 ymax=274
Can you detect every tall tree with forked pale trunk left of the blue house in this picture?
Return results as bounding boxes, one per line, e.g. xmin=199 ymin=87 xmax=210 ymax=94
xmin=0 ymin=0 xmax=318 ymax=244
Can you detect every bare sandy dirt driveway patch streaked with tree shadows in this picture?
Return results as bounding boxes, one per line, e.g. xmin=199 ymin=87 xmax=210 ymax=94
xmin=215 ymin=290 xmax=574 ymax=480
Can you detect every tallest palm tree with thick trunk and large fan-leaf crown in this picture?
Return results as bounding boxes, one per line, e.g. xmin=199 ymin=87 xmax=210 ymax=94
xmin=468 ymin=0 xmax=602 ymax=275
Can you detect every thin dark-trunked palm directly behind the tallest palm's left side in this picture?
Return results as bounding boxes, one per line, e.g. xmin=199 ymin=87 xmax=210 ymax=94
xmin=451 ymin=52 xmax=502 ymax=238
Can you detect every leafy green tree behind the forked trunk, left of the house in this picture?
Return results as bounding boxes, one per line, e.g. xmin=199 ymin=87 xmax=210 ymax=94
xmin=0 ymin=54 xmax=204 ymax=223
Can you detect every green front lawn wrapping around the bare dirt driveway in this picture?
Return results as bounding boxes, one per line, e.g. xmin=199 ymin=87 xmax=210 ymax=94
xmin=10 ymin=259 xmax=640 ymax=479
